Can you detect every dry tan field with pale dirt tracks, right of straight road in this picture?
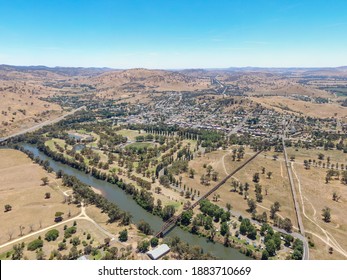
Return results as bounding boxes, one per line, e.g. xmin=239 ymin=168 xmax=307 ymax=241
xmin=293 ymin=162 xmax=347 ymax=259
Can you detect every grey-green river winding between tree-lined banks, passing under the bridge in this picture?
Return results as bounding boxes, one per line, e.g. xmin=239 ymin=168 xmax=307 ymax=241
xmin=21 ymin=143 xmax=250 ymax=260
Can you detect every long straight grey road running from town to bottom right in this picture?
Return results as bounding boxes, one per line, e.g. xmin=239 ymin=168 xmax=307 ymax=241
xmin=282 ymin=124 xmax=309 ymax=260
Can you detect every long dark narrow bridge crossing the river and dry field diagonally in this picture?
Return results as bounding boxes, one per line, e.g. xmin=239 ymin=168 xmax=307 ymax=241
xmin=155 ymin=150 xmax=262 ymax=237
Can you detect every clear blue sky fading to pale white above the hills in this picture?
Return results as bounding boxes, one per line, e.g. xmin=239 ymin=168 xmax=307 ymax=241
xmin=0 ymin=0 xmax=347 ymax=69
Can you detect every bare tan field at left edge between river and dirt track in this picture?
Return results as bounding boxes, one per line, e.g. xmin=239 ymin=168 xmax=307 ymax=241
xmin=0 ymin=150 xmax=79 ymax=244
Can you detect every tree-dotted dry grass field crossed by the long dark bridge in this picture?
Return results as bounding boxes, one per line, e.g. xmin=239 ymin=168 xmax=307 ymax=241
xmin=175 ymin=147 xmax=297 ymax=226
